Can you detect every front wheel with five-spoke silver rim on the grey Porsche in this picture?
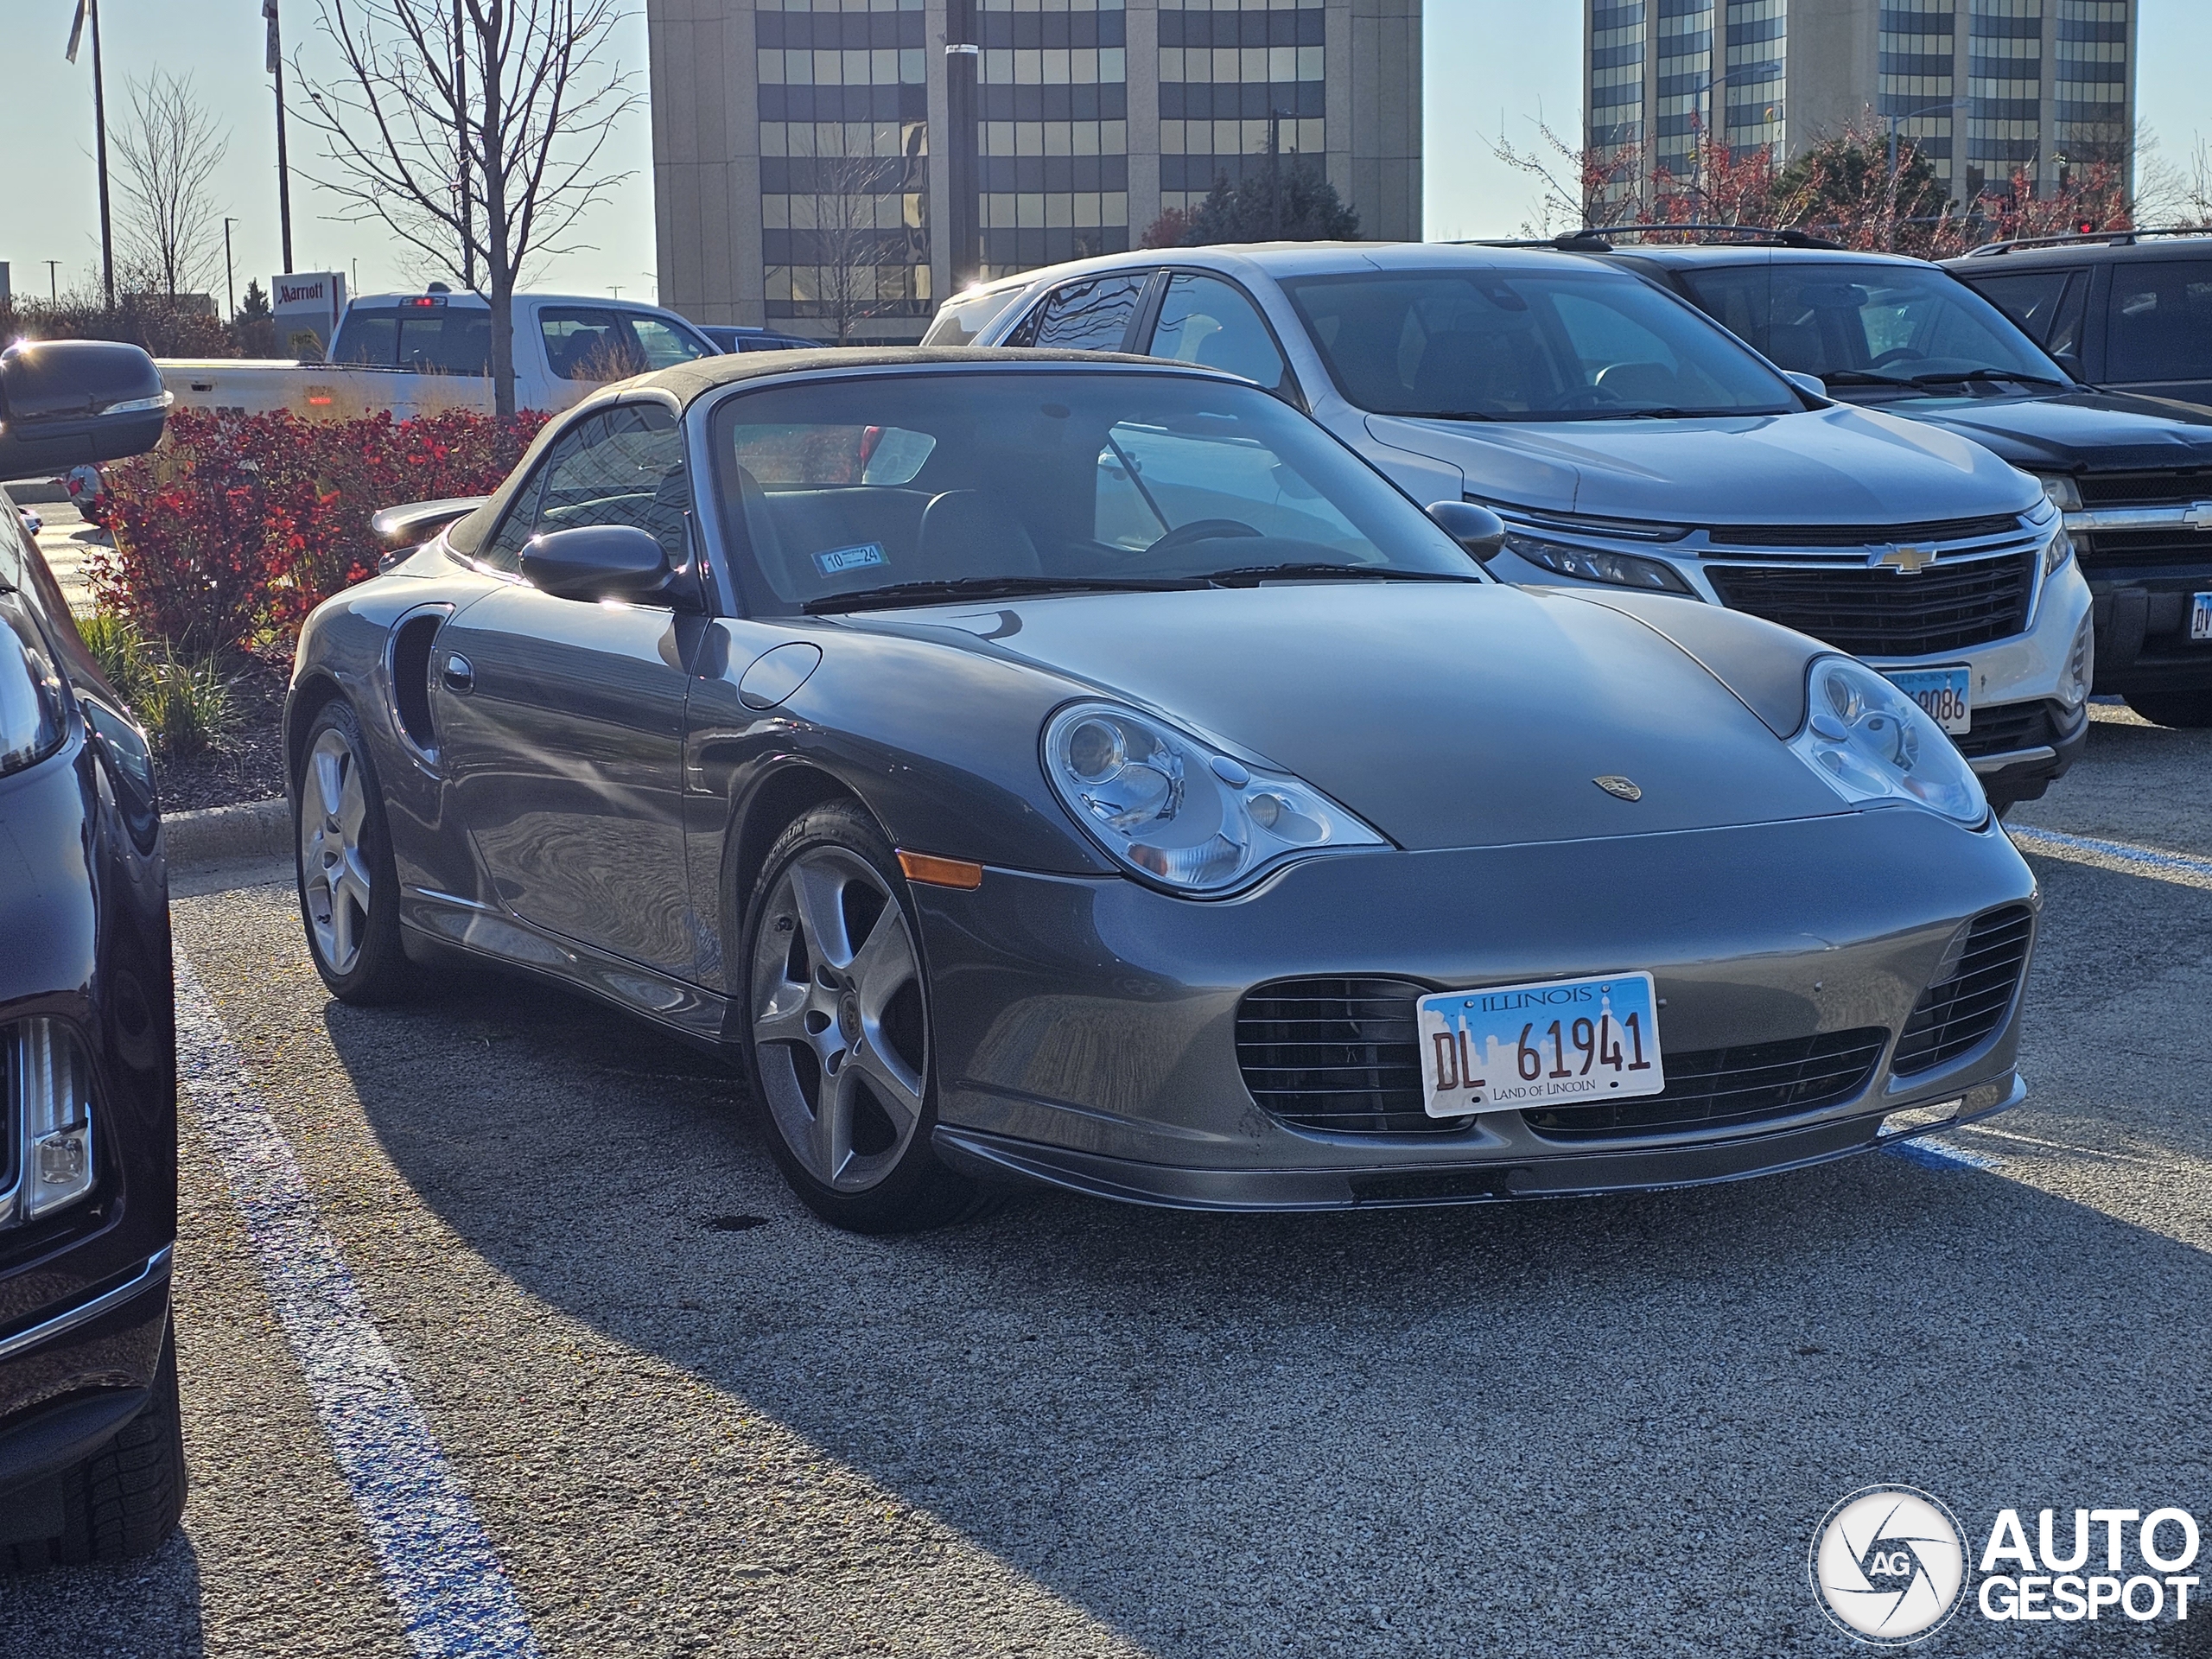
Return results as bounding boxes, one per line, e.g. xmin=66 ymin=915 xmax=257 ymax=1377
xmin=746 ymin=803 xmax=984 ymax=1232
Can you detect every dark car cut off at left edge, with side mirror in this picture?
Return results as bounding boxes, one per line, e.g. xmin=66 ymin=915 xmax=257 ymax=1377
xmin=0 ymin=340 xmax=183 ymax=1568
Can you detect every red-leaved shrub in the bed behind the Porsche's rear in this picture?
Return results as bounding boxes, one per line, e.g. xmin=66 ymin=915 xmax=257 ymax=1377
xmin=86 ymin=410 xmax=546 ymax=657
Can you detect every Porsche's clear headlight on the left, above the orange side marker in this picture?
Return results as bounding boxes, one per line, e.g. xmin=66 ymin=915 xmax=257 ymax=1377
xmin=1044 ymin=703 xmax=1389 ymax=893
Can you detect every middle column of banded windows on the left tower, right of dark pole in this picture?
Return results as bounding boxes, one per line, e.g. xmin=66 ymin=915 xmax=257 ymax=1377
xmin=976 ymin=0 xmax=1128 ymax=279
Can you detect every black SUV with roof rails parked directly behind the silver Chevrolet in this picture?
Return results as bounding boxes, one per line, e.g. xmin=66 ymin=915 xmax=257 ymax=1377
xmin=1592 ymin=232 xmax=2212 ymax=726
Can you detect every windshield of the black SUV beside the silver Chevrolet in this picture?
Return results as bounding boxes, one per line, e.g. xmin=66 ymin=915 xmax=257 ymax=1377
xmin=1683 ymin=259 xmax=2069 ymax=396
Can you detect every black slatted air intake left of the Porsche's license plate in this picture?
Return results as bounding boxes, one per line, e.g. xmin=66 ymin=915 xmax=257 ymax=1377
xmin=1236 ymin=978 xmax=1466 ymax=1135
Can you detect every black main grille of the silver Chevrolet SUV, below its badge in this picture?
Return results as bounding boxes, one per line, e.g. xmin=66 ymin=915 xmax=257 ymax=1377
xmin=1706 ymin=553 xmax=2037 ymax=657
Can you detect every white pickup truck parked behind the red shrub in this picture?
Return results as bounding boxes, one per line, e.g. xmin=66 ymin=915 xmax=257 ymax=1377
xmin=157 ymin=283 xmax=719 ymax=420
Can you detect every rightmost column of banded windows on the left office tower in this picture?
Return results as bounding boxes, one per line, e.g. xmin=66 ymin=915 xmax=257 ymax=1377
xmin=1159 ymin=0 xmax=1327 ymax=213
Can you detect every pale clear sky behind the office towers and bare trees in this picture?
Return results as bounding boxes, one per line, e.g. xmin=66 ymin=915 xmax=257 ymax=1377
xmin=0 ymin=0 xmax=2212 ymax=309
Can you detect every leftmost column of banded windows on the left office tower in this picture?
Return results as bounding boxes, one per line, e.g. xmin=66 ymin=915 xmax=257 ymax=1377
xmin=754 ymin=0 xmax=931 ymax=329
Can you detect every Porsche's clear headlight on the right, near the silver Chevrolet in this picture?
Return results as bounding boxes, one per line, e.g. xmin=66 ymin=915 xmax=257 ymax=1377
xmin=1792 ymin=657 xmax=1988 ymax=825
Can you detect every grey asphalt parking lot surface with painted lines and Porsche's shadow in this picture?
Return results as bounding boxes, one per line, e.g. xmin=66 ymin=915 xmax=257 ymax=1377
xmin=0 ymin=708 xmax=2212 ymax=1659
